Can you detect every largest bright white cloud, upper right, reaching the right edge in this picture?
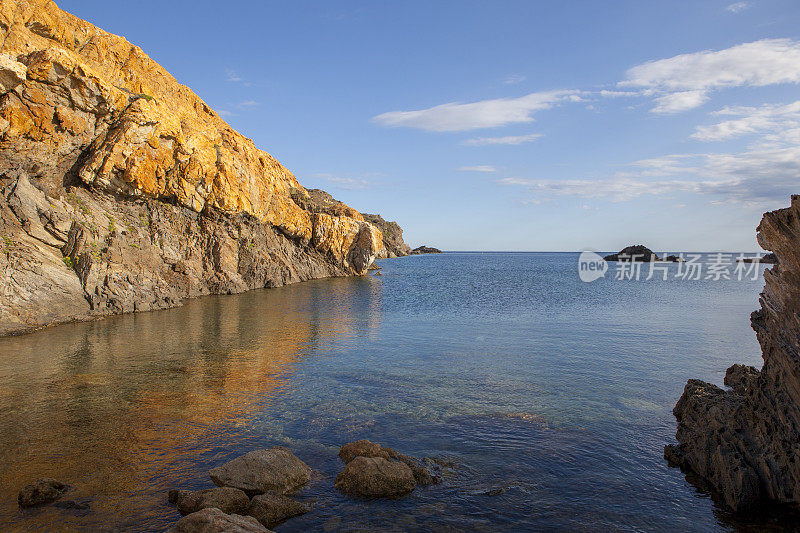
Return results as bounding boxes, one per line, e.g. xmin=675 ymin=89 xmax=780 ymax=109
xmin=619 ymin=39 xmax=800 ymax=113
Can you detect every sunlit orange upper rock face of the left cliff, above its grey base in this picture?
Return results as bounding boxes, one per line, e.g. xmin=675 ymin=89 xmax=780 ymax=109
xmin=0 ymin=0 xmax=382 ymax=274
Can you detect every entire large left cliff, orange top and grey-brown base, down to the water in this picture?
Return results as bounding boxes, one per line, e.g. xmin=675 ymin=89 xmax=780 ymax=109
xmin=0 ymin=0 xmax=383 ymax=334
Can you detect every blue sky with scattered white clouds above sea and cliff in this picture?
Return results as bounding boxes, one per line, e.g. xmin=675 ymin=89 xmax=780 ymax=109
xmin=57 ymin=0 xmax=800 ymax=251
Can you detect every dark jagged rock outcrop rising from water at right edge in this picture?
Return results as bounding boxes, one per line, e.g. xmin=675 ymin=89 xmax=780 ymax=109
xmin=664 ymin=196 xmax=800 ymax=510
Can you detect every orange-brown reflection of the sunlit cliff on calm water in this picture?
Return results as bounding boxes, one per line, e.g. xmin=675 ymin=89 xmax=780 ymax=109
xmin=0 ymin=278 xmax=381 ymax=529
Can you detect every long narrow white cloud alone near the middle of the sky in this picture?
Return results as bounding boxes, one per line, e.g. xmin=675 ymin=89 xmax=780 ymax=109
xmin=372 ymin=90 xmax=581 ymax=131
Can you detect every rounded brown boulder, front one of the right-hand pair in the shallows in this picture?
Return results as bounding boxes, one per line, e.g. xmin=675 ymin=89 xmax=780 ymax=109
xmin=335 ymin=457 xmax=417 ymax=498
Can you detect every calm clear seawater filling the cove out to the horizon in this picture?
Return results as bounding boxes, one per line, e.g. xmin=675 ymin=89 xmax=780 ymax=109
xmin=0 ymin=253 xmax=780 ymax=532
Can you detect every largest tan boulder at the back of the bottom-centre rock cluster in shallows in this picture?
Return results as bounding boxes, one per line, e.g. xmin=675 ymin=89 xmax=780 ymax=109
xmin=209 ymin=446 xmax=311 ymax=495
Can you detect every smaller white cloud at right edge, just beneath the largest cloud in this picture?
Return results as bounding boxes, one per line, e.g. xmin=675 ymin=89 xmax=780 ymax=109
xmin=692 ymin=100 xmax=800 ymax=141
